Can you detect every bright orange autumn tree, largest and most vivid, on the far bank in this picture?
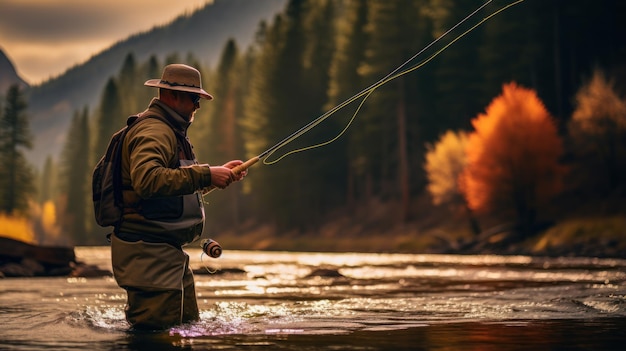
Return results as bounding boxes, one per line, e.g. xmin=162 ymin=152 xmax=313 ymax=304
xmin=461 ymin=83 xmax=563 ymax=234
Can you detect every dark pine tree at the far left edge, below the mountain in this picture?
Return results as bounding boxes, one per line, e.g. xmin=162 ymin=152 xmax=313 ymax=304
xmin=0 ymin=85 xmax=35 ymax=214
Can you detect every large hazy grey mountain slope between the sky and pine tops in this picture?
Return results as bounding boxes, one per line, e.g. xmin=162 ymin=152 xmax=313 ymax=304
xmin=21 ymin=0 xmax=286 ymax=167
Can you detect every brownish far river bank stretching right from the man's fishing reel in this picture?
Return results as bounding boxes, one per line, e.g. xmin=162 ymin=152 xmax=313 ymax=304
xmin=212 ymin=216 xmax=626 ymax=259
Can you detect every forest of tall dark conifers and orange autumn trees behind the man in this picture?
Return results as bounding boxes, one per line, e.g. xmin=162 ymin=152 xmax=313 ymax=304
xmin=0 ymin=0 xmax=626 ymax=252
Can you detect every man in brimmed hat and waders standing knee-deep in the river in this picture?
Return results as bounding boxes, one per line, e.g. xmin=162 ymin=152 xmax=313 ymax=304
xmin=111 ymin=64 xmax=245 ymax=330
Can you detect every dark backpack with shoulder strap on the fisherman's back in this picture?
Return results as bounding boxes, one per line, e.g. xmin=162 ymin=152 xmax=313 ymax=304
xmin=91 ymin=115 xmax=181 ymax=227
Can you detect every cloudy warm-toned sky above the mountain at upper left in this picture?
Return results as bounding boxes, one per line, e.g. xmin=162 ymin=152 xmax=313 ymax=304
xmin=0 ymin=0 xmax=213 ymax=84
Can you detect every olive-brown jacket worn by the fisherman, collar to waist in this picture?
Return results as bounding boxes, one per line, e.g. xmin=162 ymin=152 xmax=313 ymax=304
xmin=118 ymin=98 xmax=211 ymax=246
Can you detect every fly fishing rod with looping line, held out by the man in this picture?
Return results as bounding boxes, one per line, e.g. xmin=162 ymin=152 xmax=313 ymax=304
xmin=227 ymin=0 xmax=524 ymax=174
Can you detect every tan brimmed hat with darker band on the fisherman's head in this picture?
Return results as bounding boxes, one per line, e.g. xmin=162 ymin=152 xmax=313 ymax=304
xmin=144 ymin=63 xmax=213 ymax=100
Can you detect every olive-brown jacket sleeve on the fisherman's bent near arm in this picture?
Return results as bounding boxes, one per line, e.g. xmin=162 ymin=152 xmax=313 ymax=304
xmin=126 ymin=118 xmax=211 ymax=198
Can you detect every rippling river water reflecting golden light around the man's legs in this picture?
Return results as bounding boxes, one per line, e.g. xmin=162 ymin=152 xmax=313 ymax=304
xmin=0 ymin=247 xmax=626 ymax=350
